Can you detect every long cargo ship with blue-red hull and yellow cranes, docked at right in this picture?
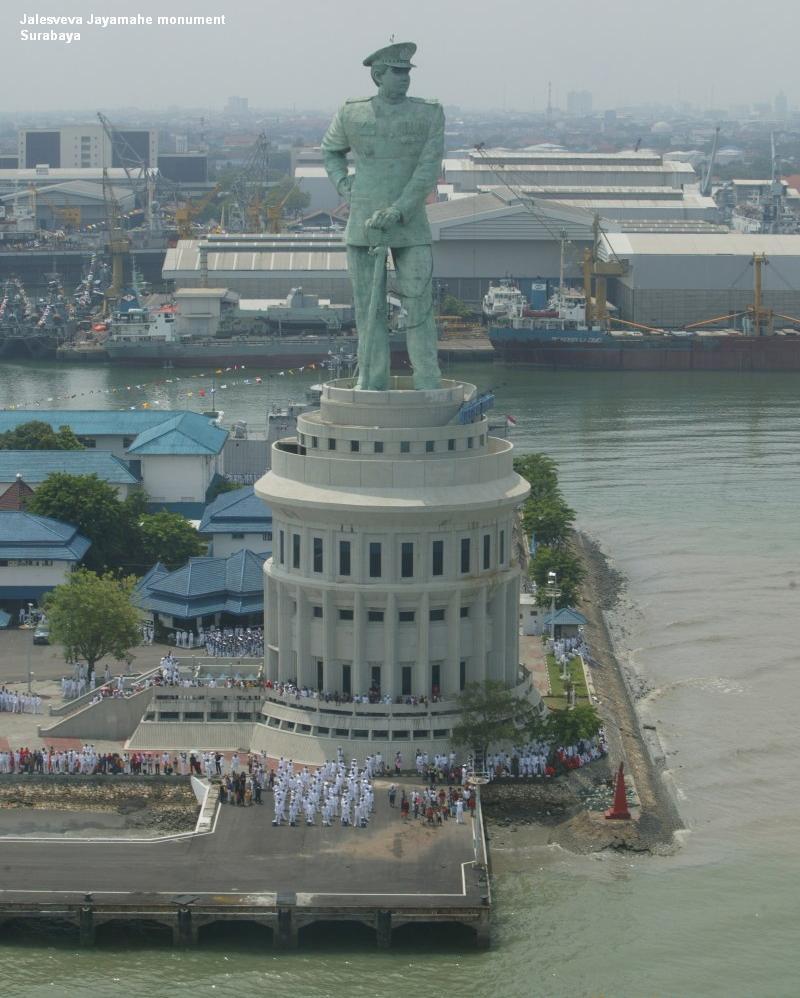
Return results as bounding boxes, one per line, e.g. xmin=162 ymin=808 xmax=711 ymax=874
xmin=488 ymin=258 xmax=800 ymax=371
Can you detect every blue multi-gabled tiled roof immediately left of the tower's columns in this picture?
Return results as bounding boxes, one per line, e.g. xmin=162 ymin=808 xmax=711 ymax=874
xmin=134 ymin=549 xmax=267 ymax=617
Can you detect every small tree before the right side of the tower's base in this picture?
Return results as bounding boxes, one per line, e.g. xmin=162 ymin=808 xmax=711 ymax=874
xmin=453 ymin=679 xmax=533 ymax=756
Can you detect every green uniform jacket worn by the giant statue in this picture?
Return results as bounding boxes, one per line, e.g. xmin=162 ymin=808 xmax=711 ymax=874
xmin=322 ymin=95 xmax=444 ymax=248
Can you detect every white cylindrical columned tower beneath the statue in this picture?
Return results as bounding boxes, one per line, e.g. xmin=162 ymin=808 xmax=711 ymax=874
xmin=256 ymin=378 xmax=528 ymax=703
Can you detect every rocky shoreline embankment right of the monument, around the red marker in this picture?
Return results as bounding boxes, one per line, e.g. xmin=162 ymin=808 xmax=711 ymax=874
xmin=481 ymin=533 xmax=683 ymax=855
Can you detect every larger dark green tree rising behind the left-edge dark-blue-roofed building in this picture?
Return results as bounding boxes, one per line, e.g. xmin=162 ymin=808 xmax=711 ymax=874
xmin=26 ymin=471 xmax=130 ymax=571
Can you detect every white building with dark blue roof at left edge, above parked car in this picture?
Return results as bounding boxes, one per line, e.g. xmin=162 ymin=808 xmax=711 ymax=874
xmin=0 ymin=510 xmax=91 ymax=610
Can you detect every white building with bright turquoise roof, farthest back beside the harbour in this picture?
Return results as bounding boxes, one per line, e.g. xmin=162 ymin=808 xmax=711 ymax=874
xmin=0 ymin=409 xmax=228 ymax=519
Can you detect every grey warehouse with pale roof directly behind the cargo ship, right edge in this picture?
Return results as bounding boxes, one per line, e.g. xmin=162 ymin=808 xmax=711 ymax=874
xmin=599 ymin=232 xmax=800 ymax=329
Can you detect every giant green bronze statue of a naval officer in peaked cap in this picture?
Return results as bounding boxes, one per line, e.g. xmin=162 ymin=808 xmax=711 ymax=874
xmin=322 ymin=42 xmax=444 ymax=391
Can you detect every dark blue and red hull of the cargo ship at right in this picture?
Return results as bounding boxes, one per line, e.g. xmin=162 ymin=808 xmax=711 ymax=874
xmin=489 ymin=329 xmax=800 ymax=372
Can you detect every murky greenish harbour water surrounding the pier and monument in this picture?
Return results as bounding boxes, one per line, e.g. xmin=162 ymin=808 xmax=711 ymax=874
xmin=0 ymin=364 xmax=800 ymax=998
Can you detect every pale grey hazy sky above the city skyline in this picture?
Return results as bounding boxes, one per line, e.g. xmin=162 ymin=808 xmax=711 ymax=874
xmin=0 ymin=0 xmax=800 ymax=111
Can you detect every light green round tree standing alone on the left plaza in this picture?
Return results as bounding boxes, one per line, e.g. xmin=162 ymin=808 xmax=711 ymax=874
xmin=44 ymin=568 xmax=141 ymax=676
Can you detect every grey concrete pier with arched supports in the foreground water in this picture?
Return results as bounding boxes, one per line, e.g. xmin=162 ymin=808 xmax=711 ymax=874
xmin=0 ymin=780 xmax=491 ymax=949
